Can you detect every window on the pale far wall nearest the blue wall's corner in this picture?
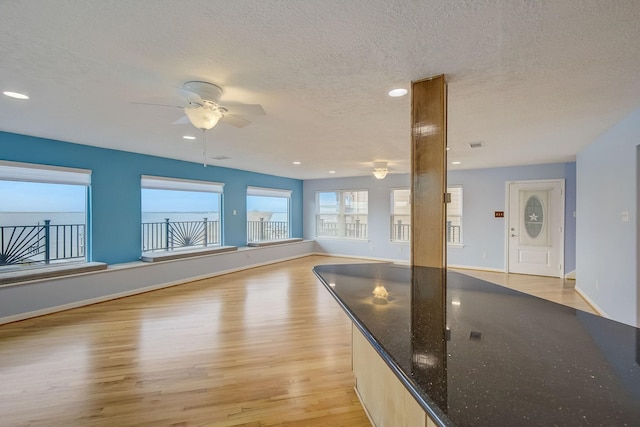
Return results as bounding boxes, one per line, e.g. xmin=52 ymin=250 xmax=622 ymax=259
xmin=316 ymin=190 xmax=369 ymax=239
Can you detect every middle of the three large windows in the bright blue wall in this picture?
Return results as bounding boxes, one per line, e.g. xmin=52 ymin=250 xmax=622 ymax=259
xmin=141 ymin=175 xmax=224 ymax=252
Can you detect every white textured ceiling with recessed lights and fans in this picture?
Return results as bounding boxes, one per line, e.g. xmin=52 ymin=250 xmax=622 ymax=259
xmin=0 ymin=0 xmax=640 ymax=179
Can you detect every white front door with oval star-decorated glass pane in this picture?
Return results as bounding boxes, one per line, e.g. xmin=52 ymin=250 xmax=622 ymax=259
xmin=507 ymin=179 xmax=564 ymax=277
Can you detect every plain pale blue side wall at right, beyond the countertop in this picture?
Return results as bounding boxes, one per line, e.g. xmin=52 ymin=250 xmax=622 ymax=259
xmin=576 ymin=109 xmax=640 ymax=325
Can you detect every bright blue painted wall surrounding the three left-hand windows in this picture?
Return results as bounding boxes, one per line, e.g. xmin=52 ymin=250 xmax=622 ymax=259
xmin=0 ymin=132 xmax=302 ymax=264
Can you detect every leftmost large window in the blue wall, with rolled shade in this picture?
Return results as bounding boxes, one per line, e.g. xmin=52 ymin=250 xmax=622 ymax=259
xmin=0 ymin=161 xmax=91 ymax=271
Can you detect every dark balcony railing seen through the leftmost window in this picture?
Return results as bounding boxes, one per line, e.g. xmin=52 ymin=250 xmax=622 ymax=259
xmin=0 ymin=219 xmax=86 ymax=266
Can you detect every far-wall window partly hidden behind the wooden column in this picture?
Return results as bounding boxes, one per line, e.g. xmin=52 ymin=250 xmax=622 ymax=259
xmin=391 ymin=185 xmax=462 ymax=244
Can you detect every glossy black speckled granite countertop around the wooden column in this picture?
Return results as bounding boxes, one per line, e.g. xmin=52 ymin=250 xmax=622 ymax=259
xmin=314 ymin=263 xmax=640 ymax=427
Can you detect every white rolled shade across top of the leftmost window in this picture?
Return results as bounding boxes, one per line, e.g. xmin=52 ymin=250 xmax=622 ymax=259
xmin=0 ymin=160 xmax=91 ymax=186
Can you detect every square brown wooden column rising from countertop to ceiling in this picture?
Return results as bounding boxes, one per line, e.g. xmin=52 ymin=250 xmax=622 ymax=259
xmin=411 ymin=75 xmax=447 ymax=268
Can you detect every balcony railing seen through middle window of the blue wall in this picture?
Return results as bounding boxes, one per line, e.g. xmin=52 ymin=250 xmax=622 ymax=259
xmin=142 ymin=218 xmax=220 ymax=252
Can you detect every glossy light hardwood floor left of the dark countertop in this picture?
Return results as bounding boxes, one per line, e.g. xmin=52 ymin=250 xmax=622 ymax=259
xmin=0 ymin=256 xmax=596 ymax=426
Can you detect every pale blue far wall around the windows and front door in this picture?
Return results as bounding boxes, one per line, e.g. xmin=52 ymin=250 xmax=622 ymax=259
xmin=303 ymin=163 xmax=576 ymax=273
